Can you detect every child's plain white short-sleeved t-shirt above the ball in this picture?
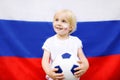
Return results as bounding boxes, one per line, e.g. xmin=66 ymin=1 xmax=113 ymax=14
xmin=42 ymin=35 xmax=82 ymax=62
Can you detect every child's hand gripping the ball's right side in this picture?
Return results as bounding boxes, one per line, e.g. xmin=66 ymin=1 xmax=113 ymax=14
xmin=74 ymin=61 xmax=87 ymax=78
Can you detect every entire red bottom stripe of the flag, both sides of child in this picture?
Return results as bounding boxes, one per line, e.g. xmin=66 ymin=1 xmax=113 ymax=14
xmin=0 ymin=55 xmax=120 ymax=80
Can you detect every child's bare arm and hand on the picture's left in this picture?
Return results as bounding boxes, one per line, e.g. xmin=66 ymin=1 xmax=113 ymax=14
xmin=42 ymin=50 xmax=64 ymax=80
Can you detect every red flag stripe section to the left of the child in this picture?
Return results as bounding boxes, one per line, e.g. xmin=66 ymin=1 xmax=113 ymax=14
xmin=0 ymin=57 xmax=45 ymax=80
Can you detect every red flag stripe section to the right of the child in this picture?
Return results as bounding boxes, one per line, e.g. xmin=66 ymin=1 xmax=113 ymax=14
xmin=81 ymin=54 xmax=120 ymax=80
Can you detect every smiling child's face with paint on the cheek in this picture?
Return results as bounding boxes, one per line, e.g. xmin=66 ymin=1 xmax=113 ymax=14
xmin=53 ymin=13 xmax=71 ymax=35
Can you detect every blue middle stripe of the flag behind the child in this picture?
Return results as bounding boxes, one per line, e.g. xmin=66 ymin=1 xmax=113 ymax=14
xmin=0 ymin=20 xmax=120 ymax=58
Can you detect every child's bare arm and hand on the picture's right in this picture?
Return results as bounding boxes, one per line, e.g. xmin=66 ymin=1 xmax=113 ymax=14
xmin=75 ymin=48 xmax=89 ymax=77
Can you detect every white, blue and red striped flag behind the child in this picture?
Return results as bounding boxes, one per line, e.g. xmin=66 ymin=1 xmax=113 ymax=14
xmin=0 ymin=0 xmax=120 ymax=80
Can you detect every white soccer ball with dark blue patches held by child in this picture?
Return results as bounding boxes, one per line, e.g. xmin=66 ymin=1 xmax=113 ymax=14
xmin=52 ymin=53 xmax=79 ymax=80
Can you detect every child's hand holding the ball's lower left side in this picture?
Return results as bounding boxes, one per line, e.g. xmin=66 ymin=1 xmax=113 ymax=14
xmin=48 ymin=68 xmax=64 ymax=80
